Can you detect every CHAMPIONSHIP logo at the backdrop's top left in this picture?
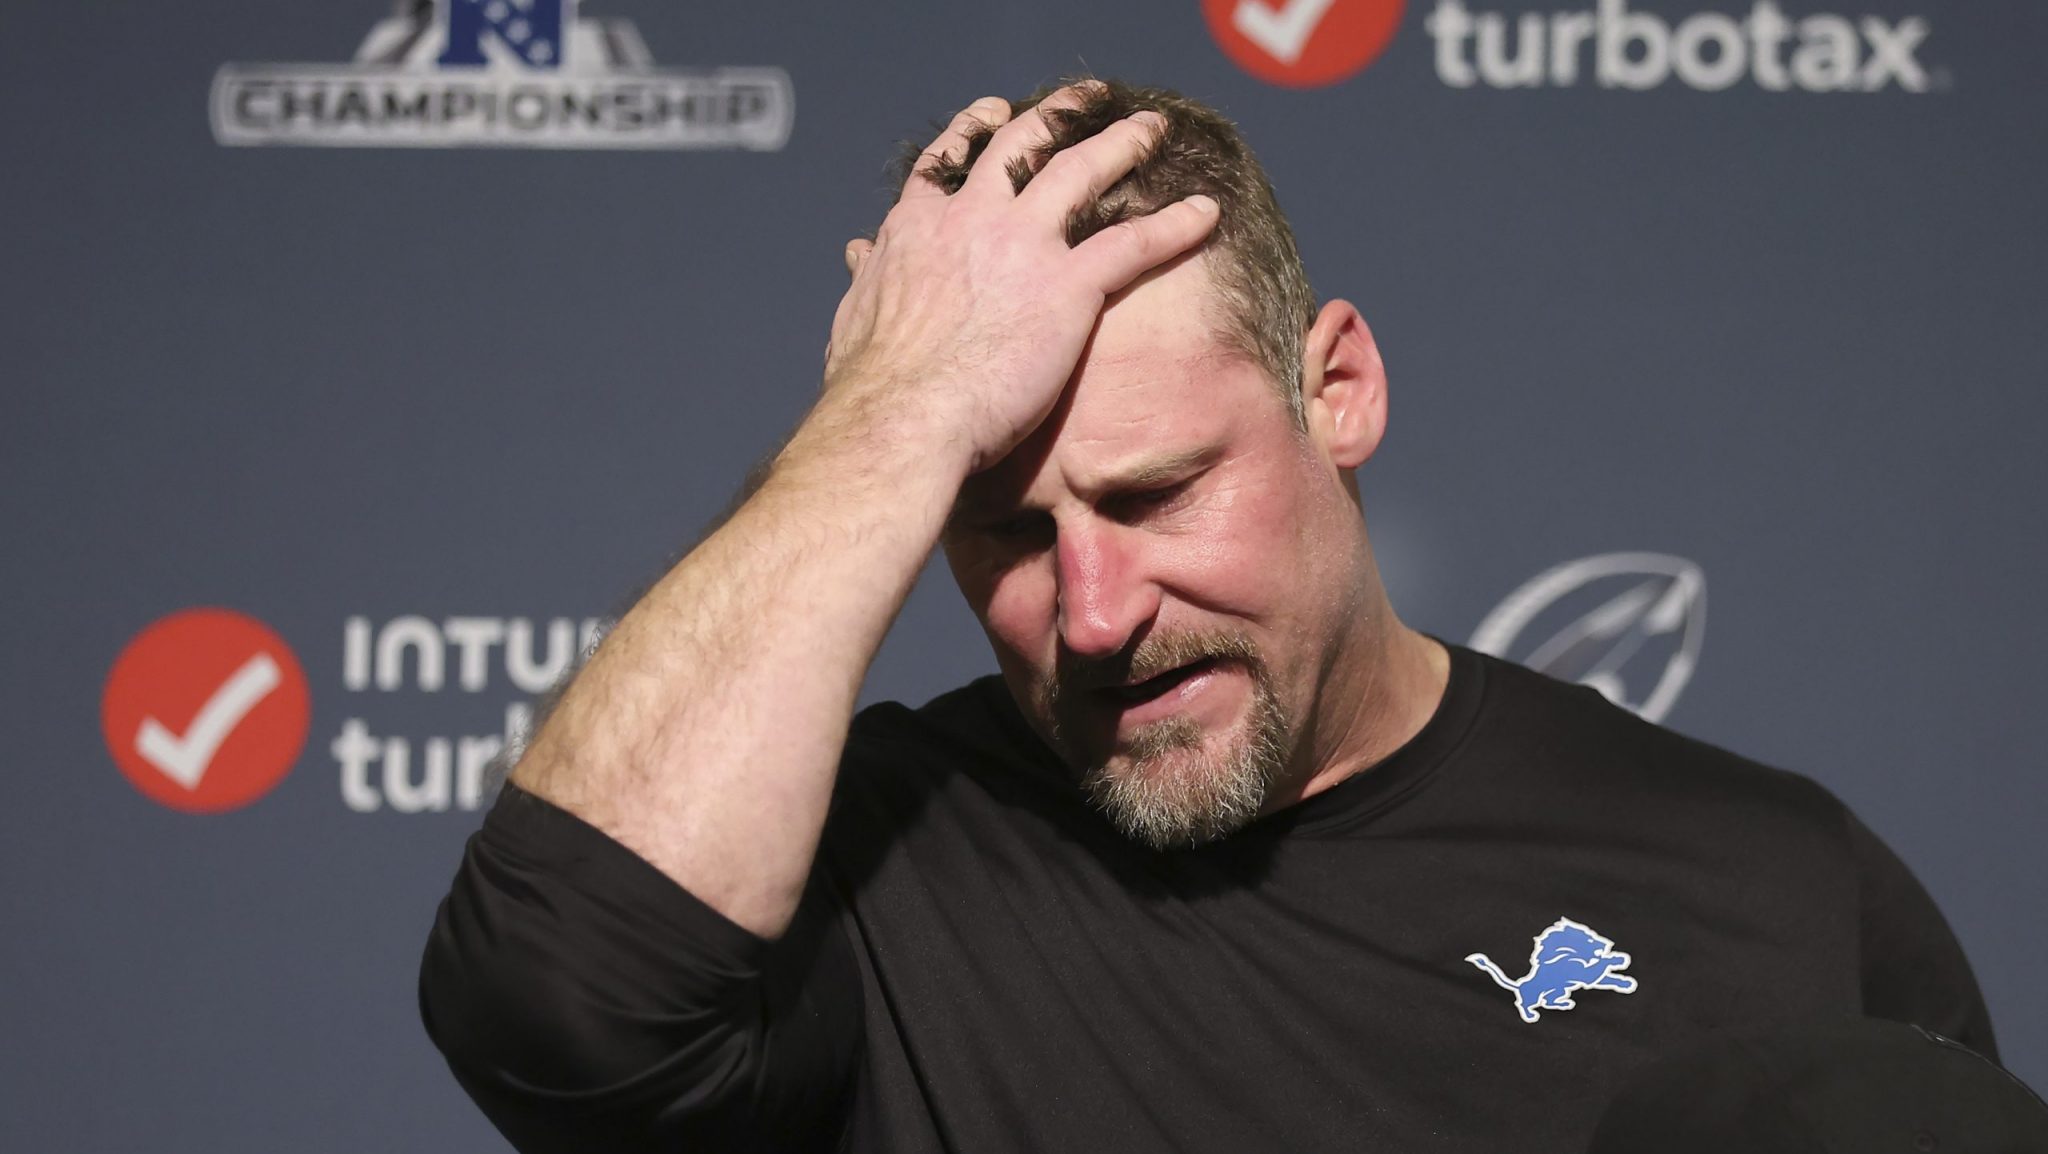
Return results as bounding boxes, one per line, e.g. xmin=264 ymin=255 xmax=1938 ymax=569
xmin=211 ymin=0 xmax=797 ymax=152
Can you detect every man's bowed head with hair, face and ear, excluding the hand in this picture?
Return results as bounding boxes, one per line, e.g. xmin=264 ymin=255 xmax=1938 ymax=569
xmin=913 ymin=86 xmax=1386 ymax=849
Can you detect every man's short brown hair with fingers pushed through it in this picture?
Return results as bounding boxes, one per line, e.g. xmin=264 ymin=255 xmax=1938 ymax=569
xmin=897 ymin=80 xmax=1315 ymax=416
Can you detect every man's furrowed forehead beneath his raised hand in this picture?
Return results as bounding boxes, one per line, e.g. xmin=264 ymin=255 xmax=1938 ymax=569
xmin=963 ymin=256 xmax=1286 ymax=504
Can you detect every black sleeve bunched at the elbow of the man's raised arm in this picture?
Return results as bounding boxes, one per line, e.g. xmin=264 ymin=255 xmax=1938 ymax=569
xmin=420 ymin=785 xmax=862 ymax=1154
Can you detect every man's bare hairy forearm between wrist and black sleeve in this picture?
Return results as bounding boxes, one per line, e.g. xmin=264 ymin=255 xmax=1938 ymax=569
xmin=512 ymin=391 xmax=965 ymax=937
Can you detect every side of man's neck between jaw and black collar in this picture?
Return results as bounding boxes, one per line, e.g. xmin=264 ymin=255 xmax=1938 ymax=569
xmin=1262 ymin=580 xmax=1450 ymax=814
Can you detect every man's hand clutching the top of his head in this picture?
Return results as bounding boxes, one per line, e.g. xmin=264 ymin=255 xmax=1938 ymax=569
xmin=825 ymin=88 xmax=1217 ymax=471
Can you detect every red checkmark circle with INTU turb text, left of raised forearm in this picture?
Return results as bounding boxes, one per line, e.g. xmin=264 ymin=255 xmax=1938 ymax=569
xmin=100 ymin=607 xmax=610 ymax=814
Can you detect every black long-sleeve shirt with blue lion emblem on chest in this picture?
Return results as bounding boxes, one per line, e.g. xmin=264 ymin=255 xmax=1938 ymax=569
xmin=420 ymin=650 xmax=1995 ymax=1154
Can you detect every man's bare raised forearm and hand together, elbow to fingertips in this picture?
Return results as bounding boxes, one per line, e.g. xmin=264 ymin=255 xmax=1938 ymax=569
xmin=497 ymin=90 xmax=1217 ymax=946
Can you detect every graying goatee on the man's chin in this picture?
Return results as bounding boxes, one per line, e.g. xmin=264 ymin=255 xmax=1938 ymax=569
xmin=1081 ymin=666 xmax=1288 ymax=851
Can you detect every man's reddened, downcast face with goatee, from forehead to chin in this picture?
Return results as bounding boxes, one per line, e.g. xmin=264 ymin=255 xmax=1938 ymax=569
xmin=944 ymin=258 xmax=1362 ymax=849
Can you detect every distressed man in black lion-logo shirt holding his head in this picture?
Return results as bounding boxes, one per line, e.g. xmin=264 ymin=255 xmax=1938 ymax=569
xmin=422 ymin=82 xmax=1993 ymax=1152
